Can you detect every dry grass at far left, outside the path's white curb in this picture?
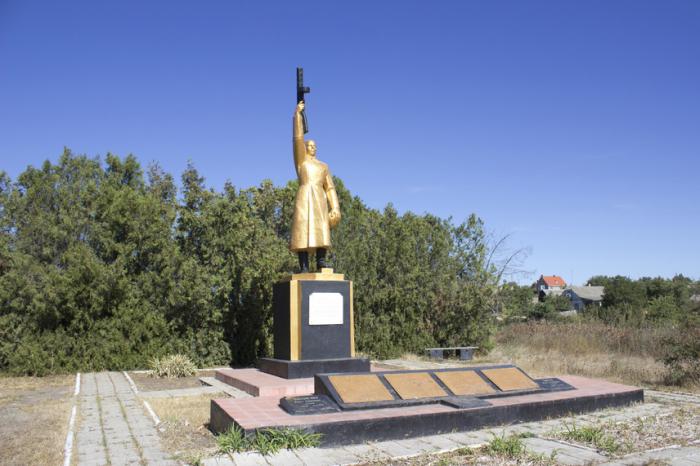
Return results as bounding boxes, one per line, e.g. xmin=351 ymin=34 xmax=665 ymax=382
xmin=0 ymin=375 xmax=75 ymax=465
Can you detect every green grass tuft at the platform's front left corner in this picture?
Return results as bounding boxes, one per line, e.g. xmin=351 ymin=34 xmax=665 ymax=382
xmin=216 ymin=426 xmax=322 ymax=455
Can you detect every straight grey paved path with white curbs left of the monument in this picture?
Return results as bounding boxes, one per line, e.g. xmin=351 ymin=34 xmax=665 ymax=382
xmin=72 ymin=372 xmax=178 ymax=466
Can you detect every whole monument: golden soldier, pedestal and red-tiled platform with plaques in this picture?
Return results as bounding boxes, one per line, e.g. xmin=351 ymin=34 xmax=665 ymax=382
xmin=210 ymin=69 xmax=644 ymax=445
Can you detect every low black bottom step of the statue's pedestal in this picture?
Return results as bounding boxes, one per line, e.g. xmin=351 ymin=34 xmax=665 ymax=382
xmin=258 ymin=358 xmax=369 ymax=379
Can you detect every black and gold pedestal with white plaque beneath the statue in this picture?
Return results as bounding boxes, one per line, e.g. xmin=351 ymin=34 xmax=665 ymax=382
xmin=258 ymin=268 xmax=369 ymax=379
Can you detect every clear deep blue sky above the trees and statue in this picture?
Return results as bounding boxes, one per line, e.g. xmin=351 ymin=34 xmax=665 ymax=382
xmin=0 ymin=0 xmax=700 ymax=283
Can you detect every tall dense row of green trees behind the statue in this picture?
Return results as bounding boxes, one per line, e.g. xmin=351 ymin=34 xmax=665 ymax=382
xmin=0 ymin=150 xmax=496 ymax=375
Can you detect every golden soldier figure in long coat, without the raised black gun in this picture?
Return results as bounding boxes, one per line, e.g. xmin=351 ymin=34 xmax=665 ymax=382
xmin=289 ymin=101 xmax=340 ymax=272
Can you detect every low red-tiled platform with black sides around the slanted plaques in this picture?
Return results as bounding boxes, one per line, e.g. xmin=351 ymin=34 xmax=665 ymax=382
xmin=211 ymin=369 xmax=644 ymax=445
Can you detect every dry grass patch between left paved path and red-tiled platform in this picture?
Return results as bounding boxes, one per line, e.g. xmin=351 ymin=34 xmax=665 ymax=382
xmin=149 ymin=394 xmax=226 ymax=462
